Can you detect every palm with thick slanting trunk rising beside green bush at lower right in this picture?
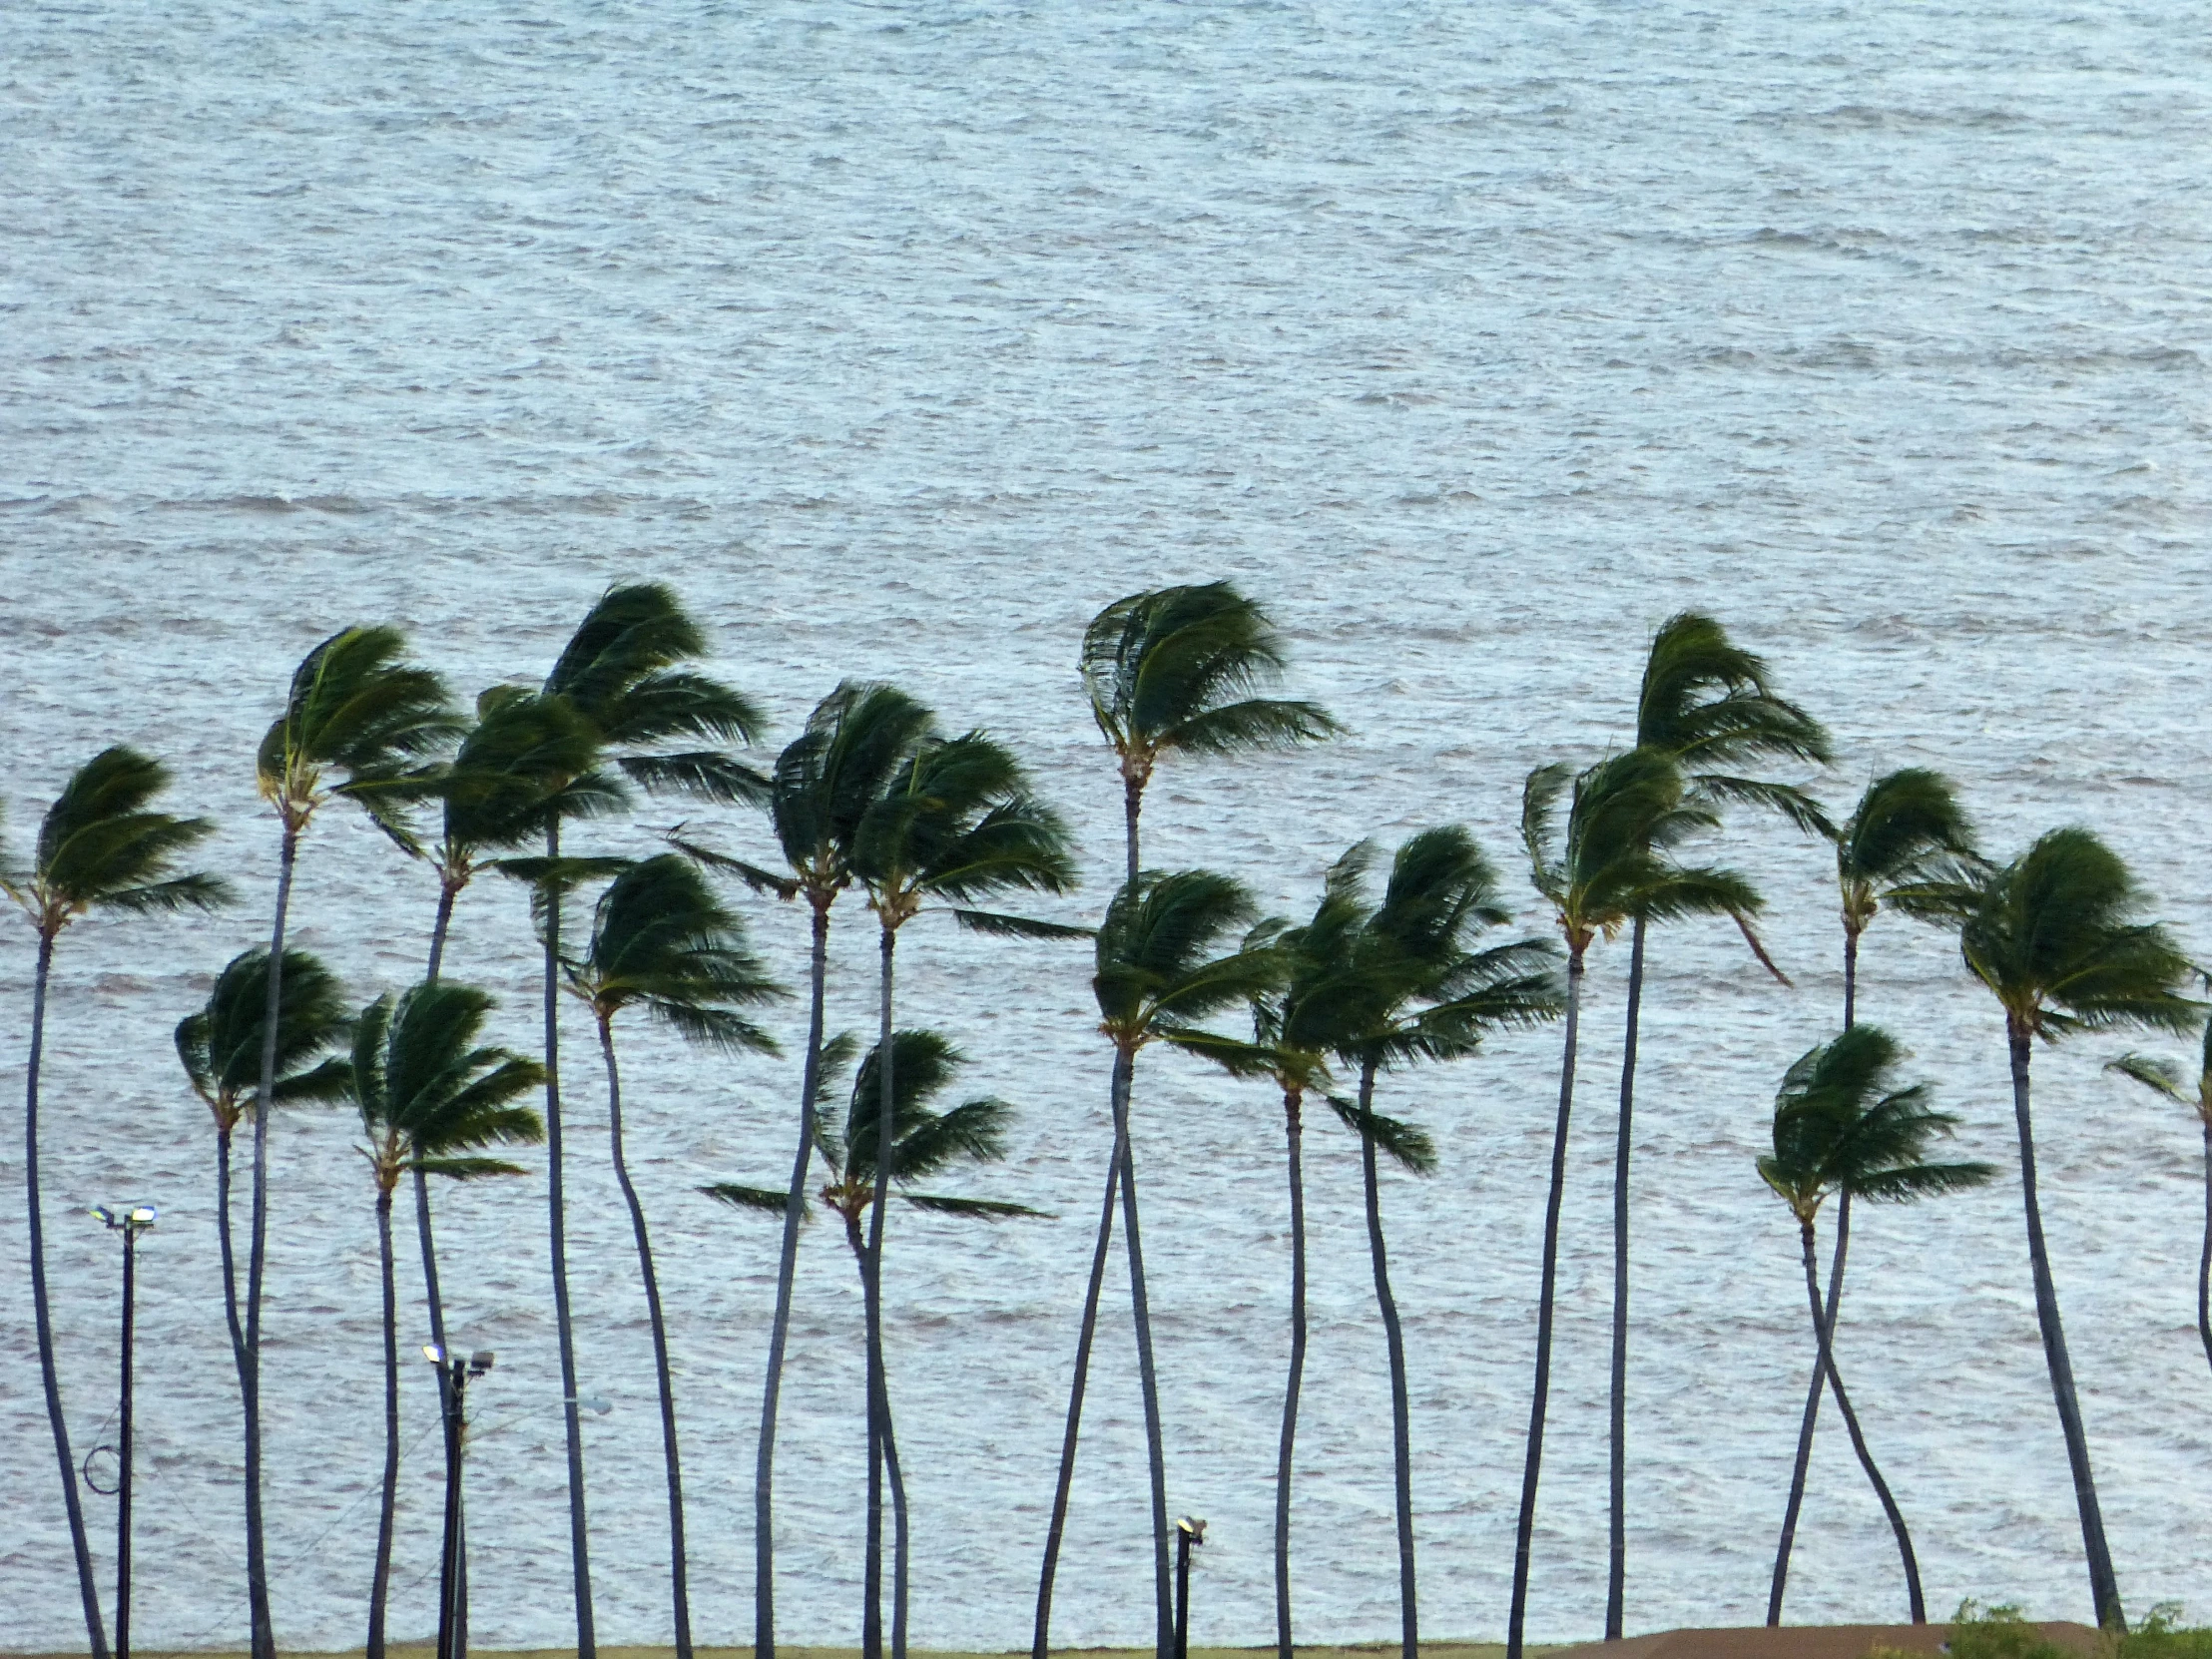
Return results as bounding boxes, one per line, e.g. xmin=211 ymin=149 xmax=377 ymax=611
xmin=1951 ymin=830 xmax=2203 ymax=1630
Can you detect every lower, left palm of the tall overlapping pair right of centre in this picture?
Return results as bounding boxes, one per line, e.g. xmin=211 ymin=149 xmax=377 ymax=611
xmin=1506 ymin=748 xmax=1757 ymax=1659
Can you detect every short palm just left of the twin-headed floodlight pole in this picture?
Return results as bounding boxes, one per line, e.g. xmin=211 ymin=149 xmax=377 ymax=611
xmin=345 ymin=980 xmax=544 ymax=1659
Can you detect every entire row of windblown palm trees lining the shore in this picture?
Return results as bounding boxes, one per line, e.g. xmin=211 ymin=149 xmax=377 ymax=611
xmin=7 ymin=584 xmax=2212 ymax=1659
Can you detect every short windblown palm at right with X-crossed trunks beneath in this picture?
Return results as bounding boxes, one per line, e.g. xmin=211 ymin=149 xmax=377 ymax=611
xmin=1759 ymin=1026 xmax=1997 ymax=1626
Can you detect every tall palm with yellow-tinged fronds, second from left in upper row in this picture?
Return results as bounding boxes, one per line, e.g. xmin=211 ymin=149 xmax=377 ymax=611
xmin=253 ymin=628 xmax=460 ymax=1659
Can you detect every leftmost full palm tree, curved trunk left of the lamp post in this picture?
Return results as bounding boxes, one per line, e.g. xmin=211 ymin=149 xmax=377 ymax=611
xmin=0 ymin=746 xmax=230 ymax=1659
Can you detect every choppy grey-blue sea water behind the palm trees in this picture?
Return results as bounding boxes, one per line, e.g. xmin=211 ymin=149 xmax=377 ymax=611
xmin=0 ymin=0 xmax=2212 ymax=1648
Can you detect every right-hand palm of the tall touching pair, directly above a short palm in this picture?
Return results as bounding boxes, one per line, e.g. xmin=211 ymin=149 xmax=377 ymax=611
xmin=851 ymin=732 xmax=1084 ymax=1659
